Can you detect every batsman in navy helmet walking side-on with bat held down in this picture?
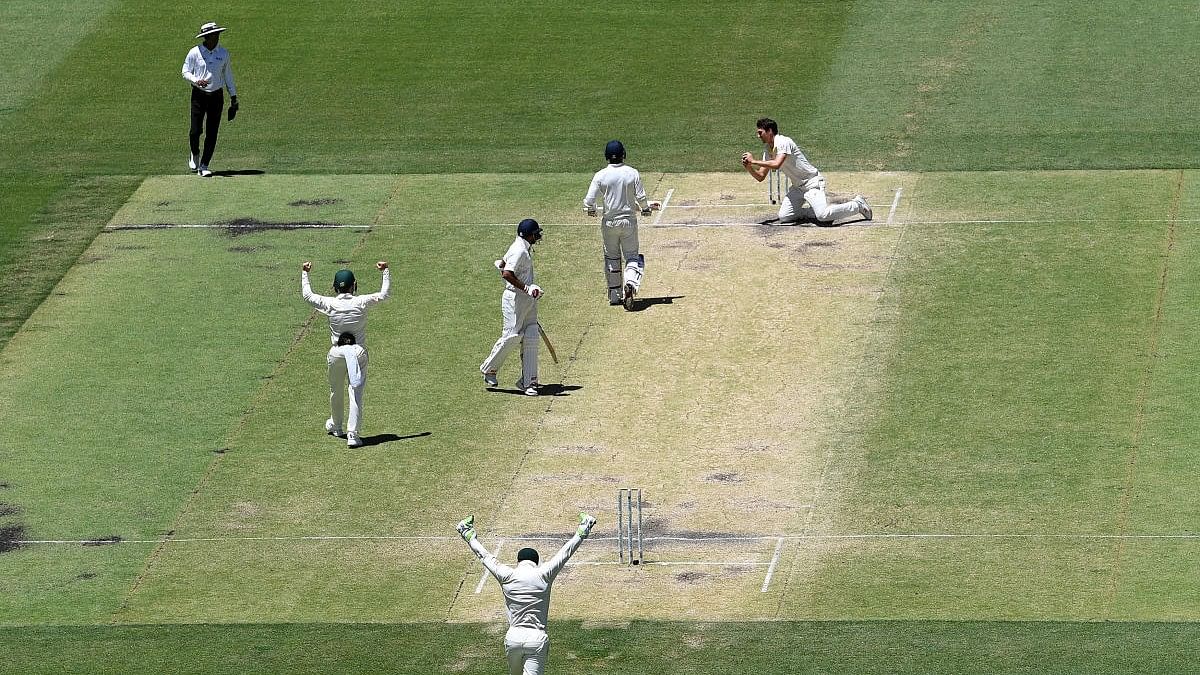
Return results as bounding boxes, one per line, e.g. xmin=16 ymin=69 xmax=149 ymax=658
xmin=479 ymin=217 xmax=542 ymax=396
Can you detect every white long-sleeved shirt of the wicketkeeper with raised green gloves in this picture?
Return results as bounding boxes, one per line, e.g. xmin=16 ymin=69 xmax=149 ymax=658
xmin=470 ymin=534 xmax=583 ymax=632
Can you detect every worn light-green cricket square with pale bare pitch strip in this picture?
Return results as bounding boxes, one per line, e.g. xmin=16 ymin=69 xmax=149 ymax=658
xmin=0 ymin=172 xmax=1198 ymax=622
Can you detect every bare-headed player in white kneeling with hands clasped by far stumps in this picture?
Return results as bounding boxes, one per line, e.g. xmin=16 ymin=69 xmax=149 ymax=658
xmin=742 ymin=118 xmax=871 ymax=222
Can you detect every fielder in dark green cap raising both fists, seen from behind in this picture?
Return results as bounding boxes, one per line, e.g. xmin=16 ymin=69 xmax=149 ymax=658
xmin=300 ymin=261 xmax=391 ymax=448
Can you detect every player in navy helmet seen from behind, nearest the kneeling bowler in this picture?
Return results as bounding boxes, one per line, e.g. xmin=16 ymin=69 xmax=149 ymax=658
xmin=583 ymin=141 xmax=660 ymax=310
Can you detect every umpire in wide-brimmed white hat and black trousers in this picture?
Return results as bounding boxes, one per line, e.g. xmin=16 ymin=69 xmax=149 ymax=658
xmin=184 ymin=22 xmax=238 ymax=178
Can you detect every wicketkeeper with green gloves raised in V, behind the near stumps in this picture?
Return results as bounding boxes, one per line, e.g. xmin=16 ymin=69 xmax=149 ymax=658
xmin=456 ymin=513 xmax=596 ymax=675
